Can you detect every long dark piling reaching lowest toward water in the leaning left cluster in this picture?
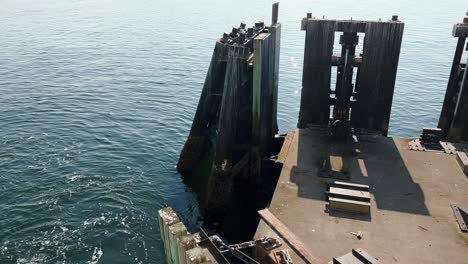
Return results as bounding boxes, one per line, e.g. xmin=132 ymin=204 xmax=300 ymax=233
xmin=206 ymin=46 xmax=248 ymax=222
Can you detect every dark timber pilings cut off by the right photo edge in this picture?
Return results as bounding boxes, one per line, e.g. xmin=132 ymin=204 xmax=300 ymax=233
xmin=438 ymin=17 xmax=468 ymax=142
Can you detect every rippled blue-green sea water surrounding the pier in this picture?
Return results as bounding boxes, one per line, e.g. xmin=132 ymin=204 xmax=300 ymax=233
xmin=0 ymin=0 xmax=468 ymax=263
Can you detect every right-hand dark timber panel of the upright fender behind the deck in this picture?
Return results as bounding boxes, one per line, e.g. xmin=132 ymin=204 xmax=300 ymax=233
xmin=351 ymin=19 xmax=404 ymax=136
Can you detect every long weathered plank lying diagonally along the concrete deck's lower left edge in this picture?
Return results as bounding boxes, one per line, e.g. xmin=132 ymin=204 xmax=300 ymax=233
xmin=258 ymin=209 xmax=324 ymax=264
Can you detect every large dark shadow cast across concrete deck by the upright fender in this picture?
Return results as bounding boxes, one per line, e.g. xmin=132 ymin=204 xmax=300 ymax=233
xmin=290 ymin=127 xmax=429 ymax=217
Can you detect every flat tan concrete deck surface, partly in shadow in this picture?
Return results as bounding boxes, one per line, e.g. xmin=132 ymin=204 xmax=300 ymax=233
xmin=256 ymin=127 xmax=468 ymax=263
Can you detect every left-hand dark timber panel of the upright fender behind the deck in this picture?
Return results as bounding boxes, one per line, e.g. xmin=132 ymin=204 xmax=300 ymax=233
xmin=297 ymin=17 xmax=336 ymax=128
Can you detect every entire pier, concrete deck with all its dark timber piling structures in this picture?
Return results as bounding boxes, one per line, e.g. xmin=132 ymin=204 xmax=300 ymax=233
xmin=170 ymin=8 xmax=468 ymax=264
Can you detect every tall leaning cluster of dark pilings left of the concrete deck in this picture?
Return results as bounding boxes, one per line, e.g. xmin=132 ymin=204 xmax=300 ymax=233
xmin=177 ymin=3 xmax=281 ymax=233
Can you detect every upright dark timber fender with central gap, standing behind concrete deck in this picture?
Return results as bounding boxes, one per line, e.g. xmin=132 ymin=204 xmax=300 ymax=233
xmin=298 ymin=13 xmax=404 ymax=135
